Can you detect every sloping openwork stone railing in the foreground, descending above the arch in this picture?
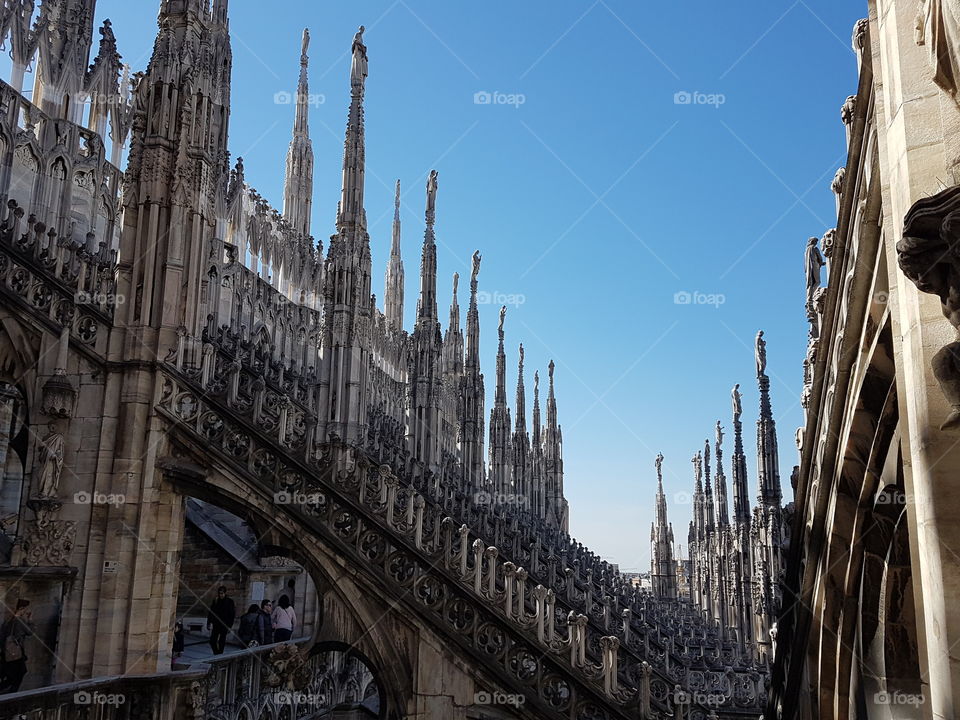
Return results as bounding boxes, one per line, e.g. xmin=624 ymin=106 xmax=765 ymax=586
xmin=158 ymin=352 xmax=764 ymax=718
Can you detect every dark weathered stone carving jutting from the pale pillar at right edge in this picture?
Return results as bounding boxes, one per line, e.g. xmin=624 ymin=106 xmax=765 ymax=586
xmin=897 ymin=186 xmax=960 ymax=430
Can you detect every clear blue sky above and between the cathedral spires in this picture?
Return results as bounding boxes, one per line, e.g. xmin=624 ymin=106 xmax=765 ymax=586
xmin=63 ymin=0 xmax=867 ymax=570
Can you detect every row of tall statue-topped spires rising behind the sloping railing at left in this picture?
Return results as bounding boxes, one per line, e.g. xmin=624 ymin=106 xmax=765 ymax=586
xmin=270 ymin=27 xmax=569 ymax=531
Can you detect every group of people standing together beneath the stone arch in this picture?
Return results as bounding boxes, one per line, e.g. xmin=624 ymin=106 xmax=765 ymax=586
xmin=201 ymin=585 xmax=297 ymax=655
